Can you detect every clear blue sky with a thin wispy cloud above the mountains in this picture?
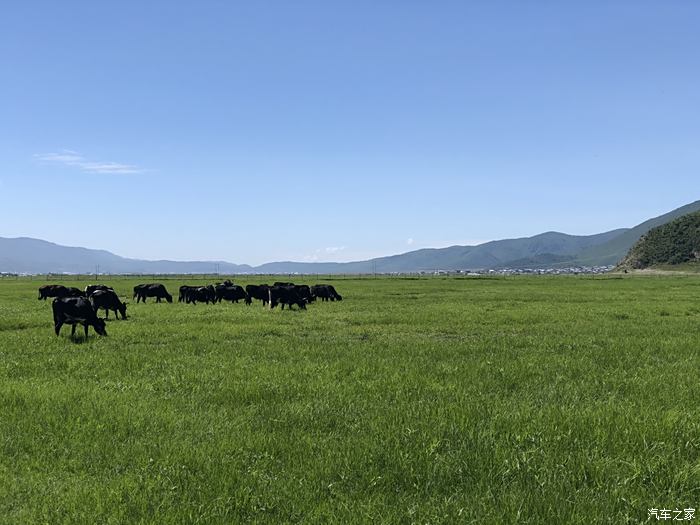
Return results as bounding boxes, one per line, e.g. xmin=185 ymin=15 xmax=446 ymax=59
xmin=0 ymin=0 xmax=700 ymax=264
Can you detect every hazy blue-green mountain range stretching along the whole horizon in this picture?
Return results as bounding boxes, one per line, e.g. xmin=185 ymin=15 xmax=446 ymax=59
xmin=0 ymin=201 xmax=700 ymax=274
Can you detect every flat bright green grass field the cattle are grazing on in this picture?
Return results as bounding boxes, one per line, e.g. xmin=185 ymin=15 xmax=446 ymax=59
xmin=0 ymin=276 xmax=700 ymax=524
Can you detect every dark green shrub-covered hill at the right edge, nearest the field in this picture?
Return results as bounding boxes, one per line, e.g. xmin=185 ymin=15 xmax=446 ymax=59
xmin=620 ymin=212 xmax=700 ymax=269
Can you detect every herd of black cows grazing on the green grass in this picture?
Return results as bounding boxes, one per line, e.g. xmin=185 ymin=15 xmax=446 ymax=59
xmin=39 ymin=280 xmax=343 ymax=338
